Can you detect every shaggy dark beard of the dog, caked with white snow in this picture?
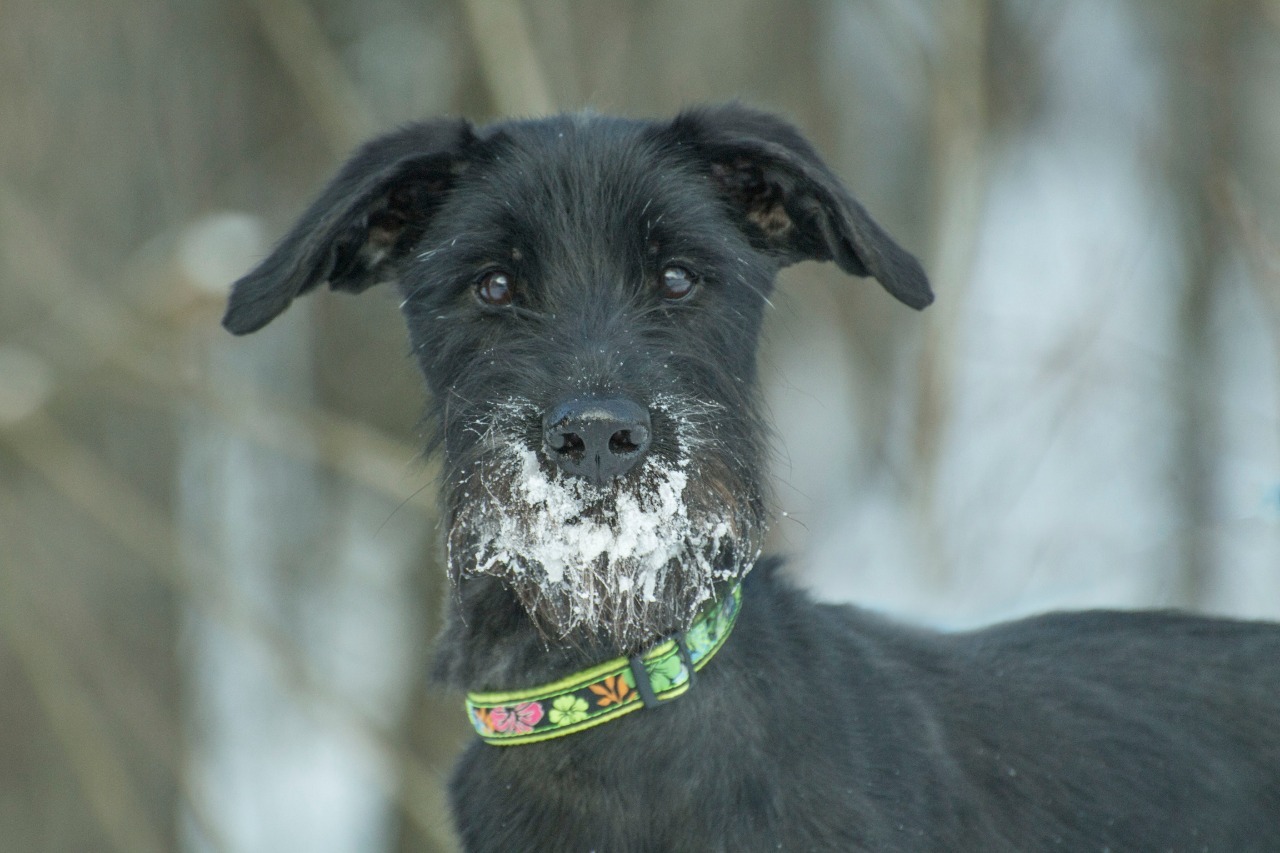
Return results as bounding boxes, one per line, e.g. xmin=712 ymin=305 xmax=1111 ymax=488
xmin=448 ymin=401 xmax=760 ymax=652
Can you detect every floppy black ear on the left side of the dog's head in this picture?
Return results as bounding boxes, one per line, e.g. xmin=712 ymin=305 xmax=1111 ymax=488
xmin=223 ymin=119 xmax=475 ymax=334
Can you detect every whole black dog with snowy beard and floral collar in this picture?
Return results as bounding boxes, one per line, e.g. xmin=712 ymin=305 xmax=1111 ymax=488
xmin=225 ymin=106 xmax=1280 ymax=853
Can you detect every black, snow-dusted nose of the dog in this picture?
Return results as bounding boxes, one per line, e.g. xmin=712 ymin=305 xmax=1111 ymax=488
xmin=543 ymin=397 xmax=650 ymax=485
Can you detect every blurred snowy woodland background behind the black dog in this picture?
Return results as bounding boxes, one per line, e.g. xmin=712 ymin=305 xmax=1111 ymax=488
xmin=0 ymin=0 xmax=1280 ymax=853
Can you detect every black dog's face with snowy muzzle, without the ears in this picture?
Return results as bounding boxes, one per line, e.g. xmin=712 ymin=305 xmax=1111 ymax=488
xmin=402 ymin=119 xmax=772 ymax=646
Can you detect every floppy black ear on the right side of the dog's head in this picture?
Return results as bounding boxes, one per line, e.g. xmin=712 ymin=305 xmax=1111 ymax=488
xmin=671 ymin=104 xmax=933 ymax=309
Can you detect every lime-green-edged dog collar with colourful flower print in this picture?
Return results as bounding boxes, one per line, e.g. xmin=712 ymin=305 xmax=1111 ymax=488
xmin=467 ymin=584 xmax=742 ymax=745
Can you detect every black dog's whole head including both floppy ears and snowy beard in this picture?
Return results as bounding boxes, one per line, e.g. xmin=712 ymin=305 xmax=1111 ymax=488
xmin=224 ymin=106 xmax=932 ymax=651
